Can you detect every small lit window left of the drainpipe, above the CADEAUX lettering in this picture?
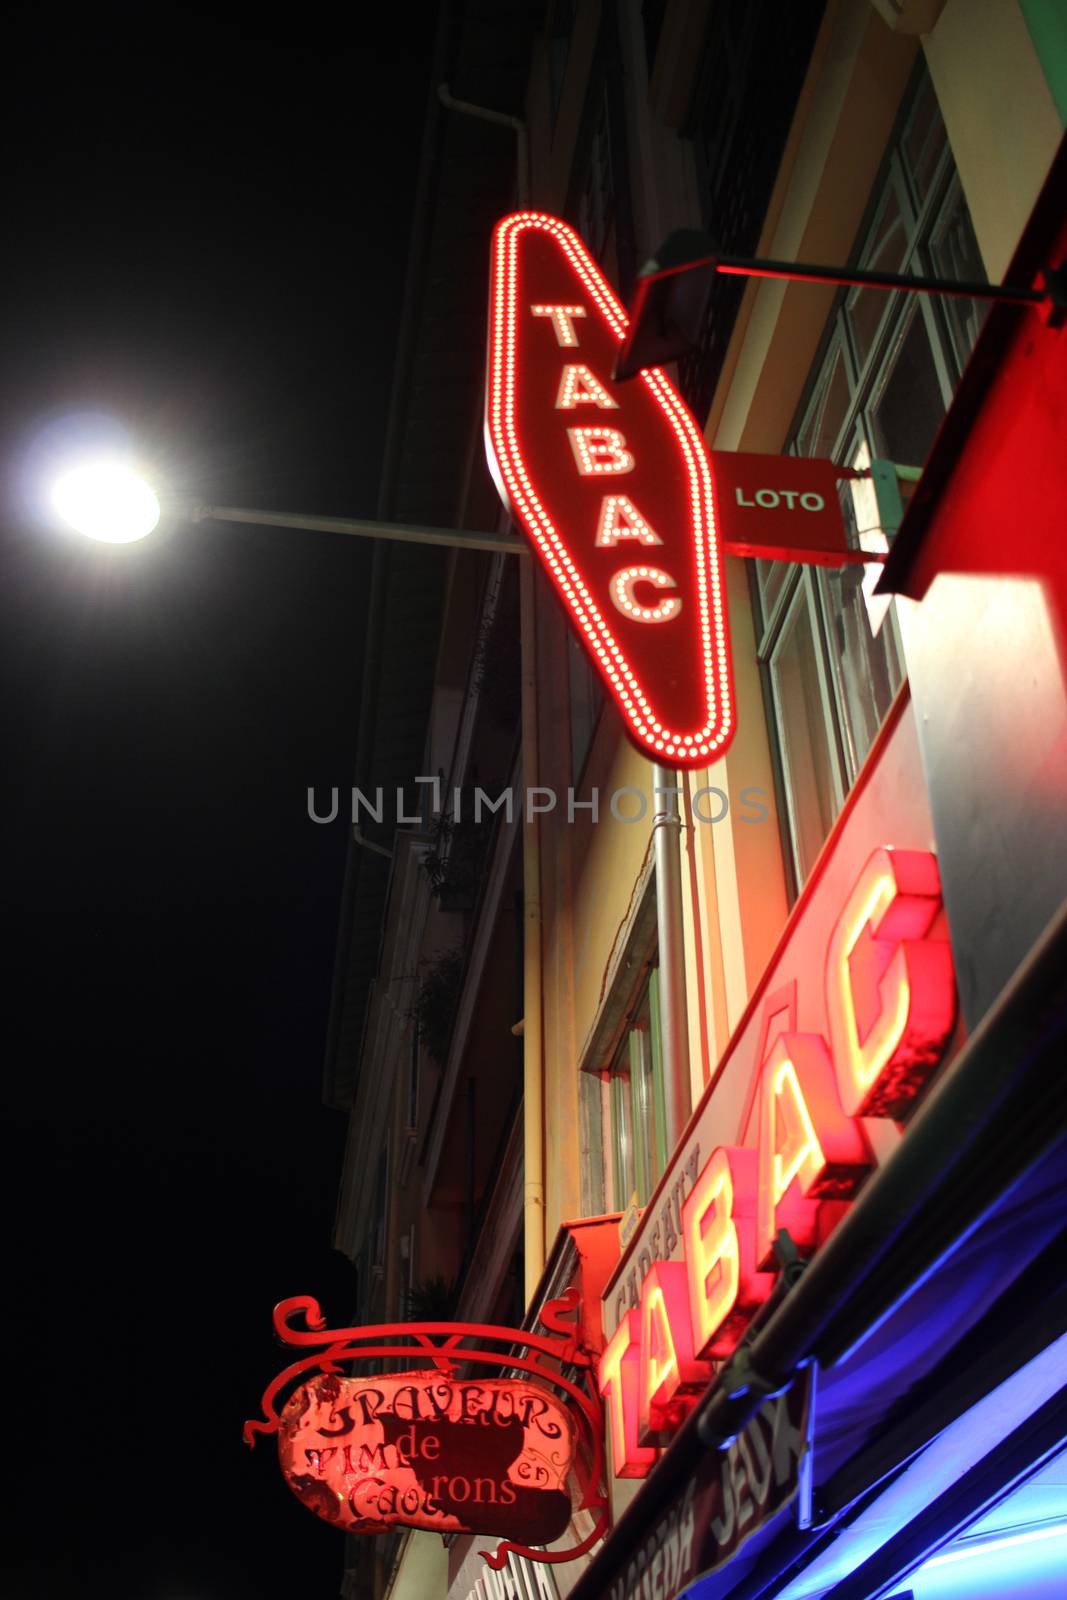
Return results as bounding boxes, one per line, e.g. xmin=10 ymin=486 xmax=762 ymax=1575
xmin=603 ymin=968 xmax=667 ymax=1211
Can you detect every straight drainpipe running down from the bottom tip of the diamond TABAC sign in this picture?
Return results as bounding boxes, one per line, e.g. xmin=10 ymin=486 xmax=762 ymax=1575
xmin=653 ymin=765 xmax=689 ymax=1152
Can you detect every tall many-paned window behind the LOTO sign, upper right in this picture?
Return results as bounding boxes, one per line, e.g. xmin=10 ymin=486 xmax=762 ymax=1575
xmin=752 ymin=67 xmax=984 ymax=890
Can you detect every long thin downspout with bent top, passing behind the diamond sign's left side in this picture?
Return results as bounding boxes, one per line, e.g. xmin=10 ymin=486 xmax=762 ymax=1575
xmin=437 ymin=83 xmax=545 ymax=1304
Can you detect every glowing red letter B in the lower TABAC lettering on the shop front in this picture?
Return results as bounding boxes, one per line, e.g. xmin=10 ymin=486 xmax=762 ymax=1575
xmin=681 ymin=1146 xmax=774 ymax=1360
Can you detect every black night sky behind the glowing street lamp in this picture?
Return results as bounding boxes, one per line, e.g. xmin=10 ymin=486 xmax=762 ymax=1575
xmin=0 ymin=3 xmax=434 ymax=1600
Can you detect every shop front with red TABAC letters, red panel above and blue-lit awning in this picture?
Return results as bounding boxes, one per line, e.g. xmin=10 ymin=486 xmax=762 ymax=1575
xmin=559 ymin=152 xmax=1067 ymax=1600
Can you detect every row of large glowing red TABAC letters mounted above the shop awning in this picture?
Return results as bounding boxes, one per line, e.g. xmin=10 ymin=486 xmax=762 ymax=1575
xmin=598 ymin=848 xmax=955 ymax=1477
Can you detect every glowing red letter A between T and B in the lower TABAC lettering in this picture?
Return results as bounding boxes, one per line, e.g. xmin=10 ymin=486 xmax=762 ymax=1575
xmin=637 ymin=1261 xmax=710 ymax=1445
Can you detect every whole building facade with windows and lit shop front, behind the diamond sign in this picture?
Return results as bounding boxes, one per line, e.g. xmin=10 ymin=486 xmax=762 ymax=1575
xmin=326 ymin=0 xmax=1067 ymax=1600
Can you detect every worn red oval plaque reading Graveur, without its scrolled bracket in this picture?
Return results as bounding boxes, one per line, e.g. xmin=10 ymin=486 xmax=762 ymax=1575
xmin=278 ymin=1371 xmax=574 ymax=1544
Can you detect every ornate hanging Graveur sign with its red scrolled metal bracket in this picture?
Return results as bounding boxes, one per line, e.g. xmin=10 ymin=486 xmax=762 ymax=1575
xmin=245 ymin=1291 xmax=606 ymax=1570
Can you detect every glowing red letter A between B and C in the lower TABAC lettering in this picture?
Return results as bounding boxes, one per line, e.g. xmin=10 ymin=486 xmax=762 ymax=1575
xmin=758 ymin=1034 xmax=872 ymax=1267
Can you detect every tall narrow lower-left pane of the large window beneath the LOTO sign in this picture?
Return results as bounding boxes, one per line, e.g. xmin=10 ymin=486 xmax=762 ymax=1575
xmin=771 ymin=584 xmax=837 ymax=880
